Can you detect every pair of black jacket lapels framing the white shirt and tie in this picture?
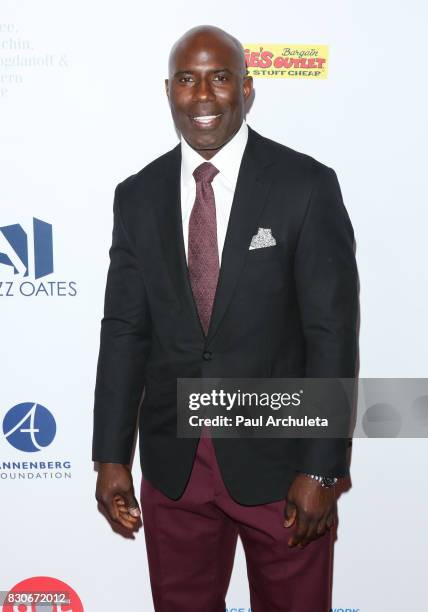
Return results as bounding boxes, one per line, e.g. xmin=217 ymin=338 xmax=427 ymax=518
xmin=155 ymin=127 xmax=272 ymax=343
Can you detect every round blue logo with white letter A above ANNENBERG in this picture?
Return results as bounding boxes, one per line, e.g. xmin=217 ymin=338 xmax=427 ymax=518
xmin=3 ymin=402 xmax=56 ymax=453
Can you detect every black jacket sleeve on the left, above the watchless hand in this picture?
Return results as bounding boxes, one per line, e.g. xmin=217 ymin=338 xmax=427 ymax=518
xmin=92 ymin=185 xmax=151 ymax=464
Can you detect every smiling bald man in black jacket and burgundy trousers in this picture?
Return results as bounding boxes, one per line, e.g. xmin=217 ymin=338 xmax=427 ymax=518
xmin=93 ymin=26 xmax=357 ymax=612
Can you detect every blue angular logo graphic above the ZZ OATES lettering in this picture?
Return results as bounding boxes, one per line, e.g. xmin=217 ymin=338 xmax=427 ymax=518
xmin=0 ymin=218 xmax=53 ymax=279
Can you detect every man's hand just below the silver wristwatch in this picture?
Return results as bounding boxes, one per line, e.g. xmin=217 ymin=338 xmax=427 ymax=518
xmin=284 ymin=474 xmax=337 ymax=548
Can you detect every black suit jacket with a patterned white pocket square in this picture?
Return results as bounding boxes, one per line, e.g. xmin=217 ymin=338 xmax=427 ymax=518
xmin=92 ymin=128 xmax=358 ymax=505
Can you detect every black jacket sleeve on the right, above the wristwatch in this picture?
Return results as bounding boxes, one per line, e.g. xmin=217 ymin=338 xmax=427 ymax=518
xmin=294 ymin=165 xmax=358 ymax=477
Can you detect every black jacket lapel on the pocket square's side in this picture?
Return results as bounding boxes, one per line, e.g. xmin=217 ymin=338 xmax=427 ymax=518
xmin=207 ymin=127 xmax=272 ymax=342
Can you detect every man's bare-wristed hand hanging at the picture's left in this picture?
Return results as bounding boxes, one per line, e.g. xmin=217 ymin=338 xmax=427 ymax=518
xmin=95 ymin=463 xmax=141 ymax=529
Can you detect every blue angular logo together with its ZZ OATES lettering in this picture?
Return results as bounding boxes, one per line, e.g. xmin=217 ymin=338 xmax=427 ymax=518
xmin=0 ymin=217 xmax=77 ymax=297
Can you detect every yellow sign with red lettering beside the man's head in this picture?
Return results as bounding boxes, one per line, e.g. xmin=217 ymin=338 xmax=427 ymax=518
xmin=244 ymin=43 xmax=328 ymax=79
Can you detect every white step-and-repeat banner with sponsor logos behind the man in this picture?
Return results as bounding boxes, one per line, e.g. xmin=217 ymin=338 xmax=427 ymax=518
xmin=0 ymin=0 xmax=428 ymax=612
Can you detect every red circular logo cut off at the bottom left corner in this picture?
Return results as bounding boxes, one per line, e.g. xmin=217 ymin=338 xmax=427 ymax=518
xmin=2 ymin=576 xmax=83 ymax=612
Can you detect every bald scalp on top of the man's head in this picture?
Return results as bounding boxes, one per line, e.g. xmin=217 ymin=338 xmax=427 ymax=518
xmin=168 ymin=25 xmax=247 ymax=78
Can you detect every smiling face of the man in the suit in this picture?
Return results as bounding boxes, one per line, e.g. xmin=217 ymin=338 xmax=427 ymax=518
xmin=165 ymin=35 xmax=252 ymax=159
